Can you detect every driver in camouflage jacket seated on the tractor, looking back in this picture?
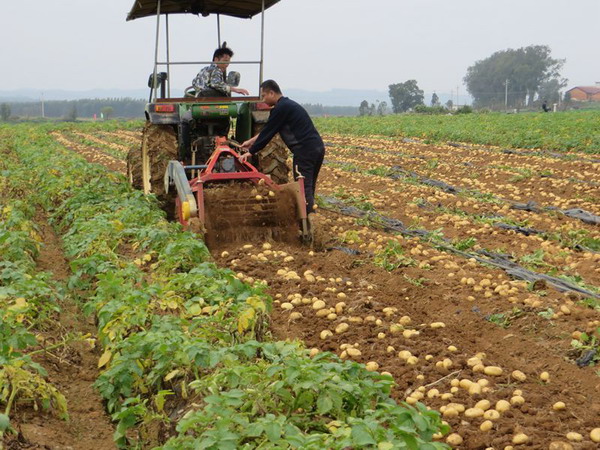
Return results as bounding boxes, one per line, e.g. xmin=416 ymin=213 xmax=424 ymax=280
xmin=192 ymin=42 xmax=248 ymax=97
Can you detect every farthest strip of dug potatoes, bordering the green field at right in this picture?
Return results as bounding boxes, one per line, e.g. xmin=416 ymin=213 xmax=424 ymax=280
xmin=328 ymin=137 xmax=600 ymax=213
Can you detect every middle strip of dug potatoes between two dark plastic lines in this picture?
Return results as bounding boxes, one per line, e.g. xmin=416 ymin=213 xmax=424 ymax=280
xmin=321 ymin=167 xmax=600 ymax=292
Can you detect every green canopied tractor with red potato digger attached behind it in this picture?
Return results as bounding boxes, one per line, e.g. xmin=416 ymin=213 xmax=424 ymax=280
xmin=122 ymin=0 xmax=312 ymax=247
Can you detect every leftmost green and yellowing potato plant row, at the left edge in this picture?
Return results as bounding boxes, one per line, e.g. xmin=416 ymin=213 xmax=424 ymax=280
xmin=0 ymin=140 xmax=67 ymax=440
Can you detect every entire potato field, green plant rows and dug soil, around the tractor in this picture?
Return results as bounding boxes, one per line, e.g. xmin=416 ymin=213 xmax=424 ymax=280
xmin=0 ymin=117 xmax=600 ymax=450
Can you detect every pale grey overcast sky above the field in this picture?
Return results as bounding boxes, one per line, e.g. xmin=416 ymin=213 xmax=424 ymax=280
xmin=0 ymin=0 xmax=600 ymax=94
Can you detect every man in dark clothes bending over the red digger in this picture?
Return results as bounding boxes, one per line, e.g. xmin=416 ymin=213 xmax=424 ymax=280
xmin=240 ymin=80 xmax=325 ymax=214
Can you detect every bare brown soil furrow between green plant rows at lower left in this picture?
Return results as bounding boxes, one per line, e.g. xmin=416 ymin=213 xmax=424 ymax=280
xmin=6 ymin=218 xmax=116 ymax=450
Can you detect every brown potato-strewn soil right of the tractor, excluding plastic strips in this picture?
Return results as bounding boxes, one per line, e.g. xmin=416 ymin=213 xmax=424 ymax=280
xmin=51 ymin=128 xmax=600 ymax=450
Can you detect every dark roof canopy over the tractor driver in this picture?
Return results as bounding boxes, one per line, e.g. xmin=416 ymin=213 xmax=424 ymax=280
xmin=127 ymin=0 xmax=279 ymax=20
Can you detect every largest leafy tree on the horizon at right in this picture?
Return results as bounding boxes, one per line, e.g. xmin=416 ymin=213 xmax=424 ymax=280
xmin=464 ymin=45 xmax=566 ymax=108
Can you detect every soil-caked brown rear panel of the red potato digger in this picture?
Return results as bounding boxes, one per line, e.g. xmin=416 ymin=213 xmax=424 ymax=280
xmin=204 ymin=183 xmax=298 ymax=248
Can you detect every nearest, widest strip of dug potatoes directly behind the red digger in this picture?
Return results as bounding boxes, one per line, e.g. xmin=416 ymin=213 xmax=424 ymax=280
xmin=220 ymin=214 xmax=599 ymax=448
